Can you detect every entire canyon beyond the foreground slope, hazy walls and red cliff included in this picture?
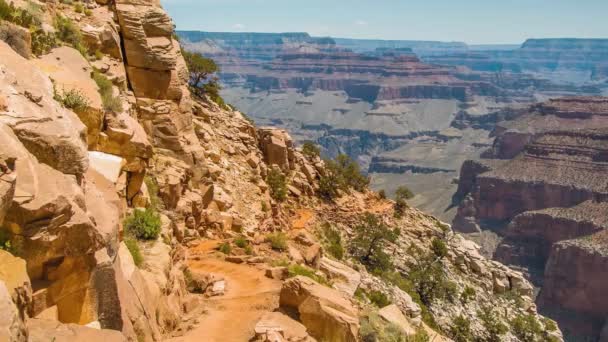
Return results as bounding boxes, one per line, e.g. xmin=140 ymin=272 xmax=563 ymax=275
xmin=179 ymin=32 xmax=608 ymax=341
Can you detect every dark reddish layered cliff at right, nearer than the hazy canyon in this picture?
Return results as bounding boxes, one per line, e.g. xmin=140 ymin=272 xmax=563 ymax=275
xmin=454 ymin=97 xmax=608 ymax=339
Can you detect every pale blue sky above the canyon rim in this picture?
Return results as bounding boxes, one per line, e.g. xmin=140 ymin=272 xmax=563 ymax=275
xmin=161 ymin=0 xmax=608 ymax=44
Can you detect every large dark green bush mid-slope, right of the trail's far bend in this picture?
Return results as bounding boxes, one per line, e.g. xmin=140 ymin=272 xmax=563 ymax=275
xmin=350 ymin=213 xmax=397 ymax=274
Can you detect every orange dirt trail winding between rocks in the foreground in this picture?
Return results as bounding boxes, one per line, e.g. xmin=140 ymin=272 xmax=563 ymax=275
xmin=169 ymin=242 xmax=281 ymax=342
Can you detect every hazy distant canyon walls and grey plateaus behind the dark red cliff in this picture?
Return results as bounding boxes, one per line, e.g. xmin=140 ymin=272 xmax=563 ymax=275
xmin=178 ymin=31 xmax=607 ymax=221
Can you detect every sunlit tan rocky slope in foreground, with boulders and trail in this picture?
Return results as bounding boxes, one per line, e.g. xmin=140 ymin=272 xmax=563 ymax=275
xmin=0 ymin=0 xmax=561 ymax=342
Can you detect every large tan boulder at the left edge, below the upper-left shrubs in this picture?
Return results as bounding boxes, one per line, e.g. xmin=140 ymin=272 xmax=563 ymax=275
xmin=0 ymin=42 xmax=88 ymax=176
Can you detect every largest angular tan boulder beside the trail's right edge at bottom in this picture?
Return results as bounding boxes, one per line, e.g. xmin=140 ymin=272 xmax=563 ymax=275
xmin=280 ymin=276 xmax=359 ymax=342
